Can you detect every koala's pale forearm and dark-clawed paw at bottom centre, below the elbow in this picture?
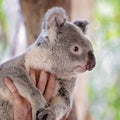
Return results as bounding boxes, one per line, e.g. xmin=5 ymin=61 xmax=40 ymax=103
xmin=37 ymin=96 xmax=71 ymax=120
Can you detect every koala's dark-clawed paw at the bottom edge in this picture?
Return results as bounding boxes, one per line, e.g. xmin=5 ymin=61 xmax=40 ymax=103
xmin=36 ymin=108 xmax=56 ymax=120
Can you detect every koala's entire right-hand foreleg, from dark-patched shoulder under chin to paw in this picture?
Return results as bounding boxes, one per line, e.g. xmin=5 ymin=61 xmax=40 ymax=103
xmin=37 ymin=79 xmax=75 ymax=120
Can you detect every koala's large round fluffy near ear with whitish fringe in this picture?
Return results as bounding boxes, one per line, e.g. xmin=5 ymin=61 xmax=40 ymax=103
xmin=43 ymin=7 xmax=67 ymax=29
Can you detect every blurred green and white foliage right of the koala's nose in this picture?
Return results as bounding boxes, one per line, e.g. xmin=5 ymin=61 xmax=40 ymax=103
xmin=88 ymin=0 xmax=120 ymax=120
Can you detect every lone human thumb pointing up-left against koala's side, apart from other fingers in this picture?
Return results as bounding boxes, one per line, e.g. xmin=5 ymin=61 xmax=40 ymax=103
xmin=4 ymin=78 xmax=22 ymax=102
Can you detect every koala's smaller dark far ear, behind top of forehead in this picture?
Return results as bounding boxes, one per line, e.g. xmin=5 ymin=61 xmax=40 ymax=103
xmin=73 ymin=20 xmax=89 ymax=34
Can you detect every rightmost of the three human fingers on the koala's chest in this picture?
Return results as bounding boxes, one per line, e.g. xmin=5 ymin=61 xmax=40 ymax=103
xmin=44 ymin=74 xmax=56 ymax=101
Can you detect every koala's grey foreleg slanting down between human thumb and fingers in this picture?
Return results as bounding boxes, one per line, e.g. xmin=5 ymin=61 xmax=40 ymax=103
xmin=7 ymin=67 xmax=47 ymax=120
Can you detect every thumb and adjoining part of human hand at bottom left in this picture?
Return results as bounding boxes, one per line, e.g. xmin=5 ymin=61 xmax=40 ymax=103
xmin=4 ymin=78 xmax=32 ymax=120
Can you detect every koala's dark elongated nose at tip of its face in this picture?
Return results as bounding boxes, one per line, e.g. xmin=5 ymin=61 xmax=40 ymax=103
xmin=86 ymin=50 xmax=96 ymax=71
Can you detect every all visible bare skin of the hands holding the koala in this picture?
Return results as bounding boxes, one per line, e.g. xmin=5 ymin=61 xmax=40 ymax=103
xmin=4 ymin=68 xmax=65 ymax=120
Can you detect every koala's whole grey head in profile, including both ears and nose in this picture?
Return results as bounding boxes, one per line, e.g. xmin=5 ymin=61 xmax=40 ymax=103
xmin=35 ymin=7 xmax=95 ymax=74
